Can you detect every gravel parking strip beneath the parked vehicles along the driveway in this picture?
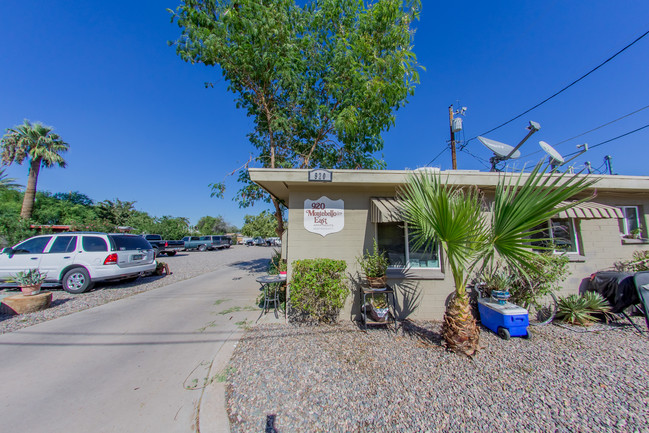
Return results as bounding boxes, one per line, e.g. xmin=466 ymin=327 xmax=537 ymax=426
xmin=0 ymin=245 xmax=273 ymax=334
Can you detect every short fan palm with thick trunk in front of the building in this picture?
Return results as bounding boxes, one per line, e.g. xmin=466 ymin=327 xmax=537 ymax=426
xmin=401 ymin=163 xmax=597 ymax=356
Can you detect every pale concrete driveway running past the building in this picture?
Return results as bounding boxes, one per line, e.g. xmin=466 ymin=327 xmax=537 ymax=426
xmin=0 ymin=260 xmax=283 ymax=433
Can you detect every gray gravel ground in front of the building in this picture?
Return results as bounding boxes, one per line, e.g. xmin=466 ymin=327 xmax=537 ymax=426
xmin=227 ymin=320 xmax=649 ymax=432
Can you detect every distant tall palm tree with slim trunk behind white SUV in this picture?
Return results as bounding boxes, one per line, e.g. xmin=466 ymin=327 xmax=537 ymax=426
xmin=0 ymin=119 xmax=70 ymax=219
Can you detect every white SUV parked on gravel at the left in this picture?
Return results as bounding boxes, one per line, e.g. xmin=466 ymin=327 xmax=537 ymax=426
xmin=0 ymin=232 xmax=156 ymax=293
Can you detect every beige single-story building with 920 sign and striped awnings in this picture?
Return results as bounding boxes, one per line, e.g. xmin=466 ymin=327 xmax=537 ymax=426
xmin=249 ymin=168 xmax=649 ymax=320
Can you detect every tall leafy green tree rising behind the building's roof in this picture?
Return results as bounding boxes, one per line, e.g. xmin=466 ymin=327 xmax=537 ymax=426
xmin=172 ymin=0 xmax=420 ymax=234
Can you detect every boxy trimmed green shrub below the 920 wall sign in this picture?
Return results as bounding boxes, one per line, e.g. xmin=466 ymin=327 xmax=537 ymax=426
xmin=289 ymin=259 xmax=349 ymax=322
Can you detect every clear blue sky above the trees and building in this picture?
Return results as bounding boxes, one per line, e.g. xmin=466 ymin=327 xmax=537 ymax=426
xmin=0 ymin=0 xmax=649 ymax=226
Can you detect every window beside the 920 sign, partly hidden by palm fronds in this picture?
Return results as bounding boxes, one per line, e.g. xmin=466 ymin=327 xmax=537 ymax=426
xmin=376 ymin=222 xmax=440 ymax=269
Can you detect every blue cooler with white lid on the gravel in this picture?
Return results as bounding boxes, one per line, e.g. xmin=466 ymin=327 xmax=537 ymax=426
xmin=478 ymin=298 xmax=530 ymax=340
